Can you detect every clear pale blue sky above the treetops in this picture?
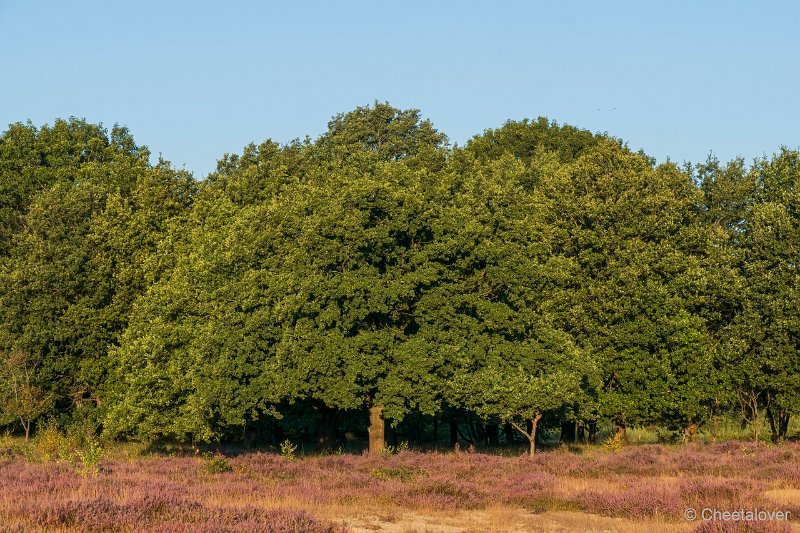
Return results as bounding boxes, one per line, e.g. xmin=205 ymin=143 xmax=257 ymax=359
xmin=0 ymin=0 xmax=800 ymax=178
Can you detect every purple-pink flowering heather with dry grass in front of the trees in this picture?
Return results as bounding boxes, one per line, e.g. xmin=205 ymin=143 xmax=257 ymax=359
xmin=0 ymin=443 xmax=800 ymax=533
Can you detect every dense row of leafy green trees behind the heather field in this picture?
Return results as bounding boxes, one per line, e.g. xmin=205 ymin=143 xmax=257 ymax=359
xmin=0 ymin=103 xmax=800 ymax=453
